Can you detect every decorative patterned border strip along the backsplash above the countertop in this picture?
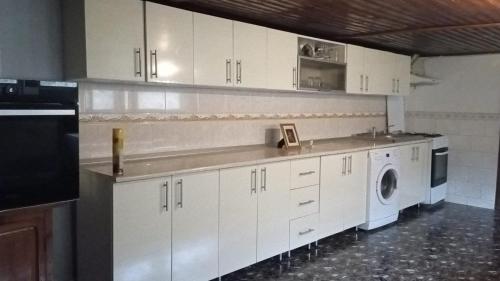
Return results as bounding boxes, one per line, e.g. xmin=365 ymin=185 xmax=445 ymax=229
xmin=80 ymin=112 xmax=385 ymax=122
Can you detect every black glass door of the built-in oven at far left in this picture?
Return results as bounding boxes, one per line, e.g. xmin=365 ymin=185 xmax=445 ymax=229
xmin=0 ymin=105 xmax=79 ymax=211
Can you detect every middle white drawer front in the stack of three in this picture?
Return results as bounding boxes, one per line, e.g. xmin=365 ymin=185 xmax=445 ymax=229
xmin=290 ymin=185 xmax=319 ymax=219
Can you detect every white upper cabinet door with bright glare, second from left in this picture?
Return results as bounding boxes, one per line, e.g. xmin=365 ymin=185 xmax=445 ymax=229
xmin=146 ymin=2 xmax=193 ymax=84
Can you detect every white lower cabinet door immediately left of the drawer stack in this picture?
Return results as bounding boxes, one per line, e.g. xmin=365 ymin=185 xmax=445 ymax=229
xmin=257 ymin=161 xmax=290 ymax=261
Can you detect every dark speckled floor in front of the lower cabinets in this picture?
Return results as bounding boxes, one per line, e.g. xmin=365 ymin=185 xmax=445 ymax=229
xmin=222 ymin=203 xmax=500 ymax=281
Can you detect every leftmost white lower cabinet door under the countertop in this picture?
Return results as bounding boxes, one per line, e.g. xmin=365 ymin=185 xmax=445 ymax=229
xmin=113 ymin=178 xmax=172 ymax=281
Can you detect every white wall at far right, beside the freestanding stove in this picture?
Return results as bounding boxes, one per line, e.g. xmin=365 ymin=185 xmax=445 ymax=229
xmin=406 ymin=55 xmax=500 ymax=209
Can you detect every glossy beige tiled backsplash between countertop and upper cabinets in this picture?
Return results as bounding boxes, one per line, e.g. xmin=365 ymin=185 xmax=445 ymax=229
xmin=80 ymin=82 xmax=385 ymax=159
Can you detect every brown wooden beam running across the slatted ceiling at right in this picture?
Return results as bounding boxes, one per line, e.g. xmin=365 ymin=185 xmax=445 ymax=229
xmin=337 ymin=22 xmax=500 ymax=39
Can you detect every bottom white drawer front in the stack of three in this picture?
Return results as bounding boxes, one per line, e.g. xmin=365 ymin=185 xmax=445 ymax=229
xmin=290 ymin=214 xmax=319 ymax=250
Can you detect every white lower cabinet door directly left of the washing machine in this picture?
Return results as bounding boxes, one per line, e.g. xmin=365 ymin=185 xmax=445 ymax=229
xmin=342 ymin=152 xmax=368 ymax=229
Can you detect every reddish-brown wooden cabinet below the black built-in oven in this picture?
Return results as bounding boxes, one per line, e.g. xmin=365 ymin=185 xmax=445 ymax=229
xmin=0 ymin=208 xmax=52 ymax=281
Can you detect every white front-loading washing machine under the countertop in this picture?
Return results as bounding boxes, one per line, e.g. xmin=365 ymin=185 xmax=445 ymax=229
xmin=359 ymin=148 xmax=400 ymax=230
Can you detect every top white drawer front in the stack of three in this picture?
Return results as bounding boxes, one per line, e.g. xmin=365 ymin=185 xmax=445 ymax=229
xmin=291 ymin=157 xmax=319 ymax=189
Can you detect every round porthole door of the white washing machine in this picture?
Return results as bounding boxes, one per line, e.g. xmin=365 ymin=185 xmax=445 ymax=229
xmin=377 ymin=164 xmax=399 ymax=205
